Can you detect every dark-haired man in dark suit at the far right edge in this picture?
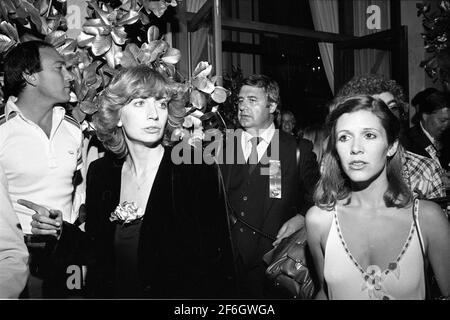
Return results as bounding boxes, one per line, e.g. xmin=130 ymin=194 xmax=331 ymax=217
xmin=402 ymin=89 xmax=450 ymax=170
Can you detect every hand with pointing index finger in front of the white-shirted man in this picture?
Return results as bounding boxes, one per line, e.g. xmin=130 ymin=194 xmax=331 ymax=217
xmin=17 ymin=199 xmax=63 ymax=237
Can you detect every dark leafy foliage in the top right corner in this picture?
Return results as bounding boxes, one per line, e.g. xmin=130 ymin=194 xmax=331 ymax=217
xmin=416 ymin=0 xmax=450 ymax=88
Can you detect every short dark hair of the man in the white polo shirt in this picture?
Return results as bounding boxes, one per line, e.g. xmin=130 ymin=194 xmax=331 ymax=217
xmin=3 ymin=40 xmax=54 ymax=98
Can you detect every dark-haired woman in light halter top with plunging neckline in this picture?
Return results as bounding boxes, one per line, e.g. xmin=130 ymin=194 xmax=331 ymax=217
xmin=306 ymin=96 xmax=450 ymax=299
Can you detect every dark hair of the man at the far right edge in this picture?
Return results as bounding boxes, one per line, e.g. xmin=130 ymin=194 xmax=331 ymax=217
xmin=411 ymin=88 xmax=450 ymax=114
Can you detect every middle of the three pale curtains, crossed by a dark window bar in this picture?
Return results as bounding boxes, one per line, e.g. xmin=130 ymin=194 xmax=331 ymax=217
xmin=309 ymin=0 xmax=339 ymax=94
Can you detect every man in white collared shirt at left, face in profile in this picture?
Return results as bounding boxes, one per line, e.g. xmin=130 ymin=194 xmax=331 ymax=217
xmin=0 ymin=41 xmax=82 ymax=298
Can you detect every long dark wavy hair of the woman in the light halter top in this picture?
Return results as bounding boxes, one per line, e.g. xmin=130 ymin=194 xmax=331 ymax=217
xmin=314 ymin=95 xmax=412 ymax=210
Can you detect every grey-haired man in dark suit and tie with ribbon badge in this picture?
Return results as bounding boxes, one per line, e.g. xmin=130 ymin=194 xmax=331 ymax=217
xmin=223 ymin=75 xmax=319 ymax=298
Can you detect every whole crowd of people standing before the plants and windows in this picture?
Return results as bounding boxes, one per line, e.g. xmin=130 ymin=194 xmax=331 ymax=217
xmin=0 ymin=41 xmax=450 ymax=299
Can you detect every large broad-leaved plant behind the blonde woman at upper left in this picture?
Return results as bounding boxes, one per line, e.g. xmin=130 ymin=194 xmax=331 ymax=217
xmin=0 ymin=0 xmax=230 ymax=140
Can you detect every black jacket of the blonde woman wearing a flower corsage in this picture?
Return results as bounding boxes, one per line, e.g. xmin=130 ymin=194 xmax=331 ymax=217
xmin=54 ymin=148 xmax=236 ymax=298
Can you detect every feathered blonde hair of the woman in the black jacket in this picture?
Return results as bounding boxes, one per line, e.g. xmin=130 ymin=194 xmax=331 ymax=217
xmin=93 ymin=65 xmax=184 ymax=158
